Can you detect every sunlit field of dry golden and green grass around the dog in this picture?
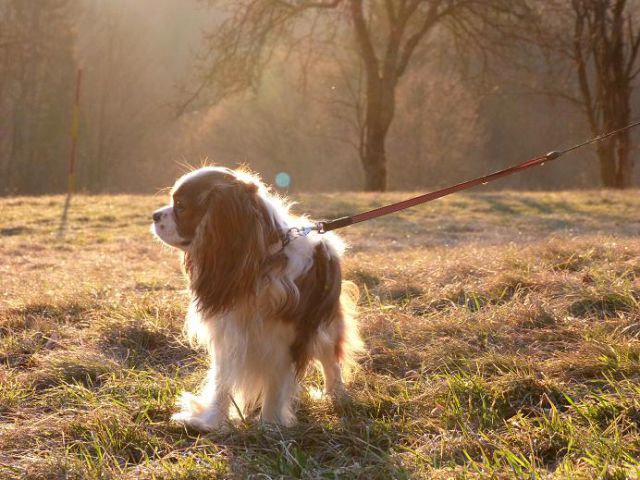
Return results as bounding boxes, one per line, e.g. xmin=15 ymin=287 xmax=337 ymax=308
xmin=0 ymin=191 xmax=640 ymax=479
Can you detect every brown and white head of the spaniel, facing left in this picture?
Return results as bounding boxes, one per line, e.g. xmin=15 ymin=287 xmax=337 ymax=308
xmin=152 ymin=167 xmax=281 ymax=313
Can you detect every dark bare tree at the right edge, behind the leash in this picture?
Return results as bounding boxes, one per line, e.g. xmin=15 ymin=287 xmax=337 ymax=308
xmin=504 ymin=0 xmax=640 ymax=188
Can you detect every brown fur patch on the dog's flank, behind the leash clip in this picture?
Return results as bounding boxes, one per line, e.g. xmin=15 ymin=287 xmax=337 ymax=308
xmin=283 ymin=243 xmax=342 ymax=376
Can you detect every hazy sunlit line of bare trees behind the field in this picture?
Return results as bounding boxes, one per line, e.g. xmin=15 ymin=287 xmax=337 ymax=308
xmin=0 ymin=0 xmax=640 ymax=194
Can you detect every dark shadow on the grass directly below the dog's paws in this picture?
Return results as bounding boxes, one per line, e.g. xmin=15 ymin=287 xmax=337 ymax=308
xmin=168 ymin=403 xmax=409 ymax=479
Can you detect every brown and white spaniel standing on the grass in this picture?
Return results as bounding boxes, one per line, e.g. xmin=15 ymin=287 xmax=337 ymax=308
xmin=152 ymin=167 xmax=362 ymax=431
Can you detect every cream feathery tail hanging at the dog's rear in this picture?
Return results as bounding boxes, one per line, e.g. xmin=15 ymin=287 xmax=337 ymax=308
xmin=336 ymin=280 xmax=364 ymax=379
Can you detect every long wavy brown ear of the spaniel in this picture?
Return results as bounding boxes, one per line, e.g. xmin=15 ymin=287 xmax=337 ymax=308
xmin=185 ymin=179 xmax=278 ymax=314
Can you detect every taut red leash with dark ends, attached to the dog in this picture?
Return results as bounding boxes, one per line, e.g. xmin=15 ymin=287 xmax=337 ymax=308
xmin=314 ymin=121 xmax=640 ymax=235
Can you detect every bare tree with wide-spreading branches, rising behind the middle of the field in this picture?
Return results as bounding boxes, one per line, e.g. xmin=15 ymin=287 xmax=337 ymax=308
xmin=186 ymin=0 xmax=509 ymax=191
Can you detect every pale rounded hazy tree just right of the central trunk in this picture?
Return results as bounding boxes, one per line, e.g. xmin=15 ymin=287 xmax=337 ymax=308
xmin=389 ymin=65 xmax=488 ymax=188
